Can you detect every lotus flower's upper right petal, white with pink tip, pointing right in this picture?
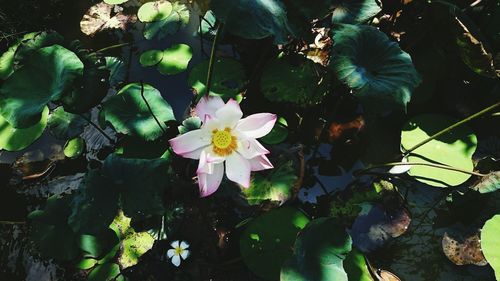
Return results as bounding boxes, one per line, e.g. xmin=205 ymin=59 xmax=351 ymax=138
xmin=236 ymin=113 xmax=276 ymax=139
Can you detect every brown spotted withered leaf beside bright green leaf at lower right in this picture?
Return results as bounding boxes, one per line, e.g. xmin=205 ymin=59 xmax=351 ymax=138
xmin=442 ymin=232 xmax=487 ymax=266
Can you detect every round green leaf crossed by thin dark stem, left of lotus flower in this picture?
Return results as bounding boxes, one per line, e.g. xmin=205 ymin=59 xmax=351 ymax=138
xmin=102 ymin=83 xmax=175 ymax=140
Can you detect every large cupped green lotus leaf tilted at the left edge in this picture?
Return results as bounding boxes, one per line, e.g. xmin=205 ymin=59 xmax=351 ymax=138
xmin=0 ymin=45 xmax=83 ymax=128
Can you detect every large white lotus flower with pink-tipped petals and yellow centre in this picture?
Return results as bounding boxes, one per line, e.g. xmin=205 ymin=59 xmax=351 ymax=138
xmin=170 ymin=97 xmax=276 ymax=197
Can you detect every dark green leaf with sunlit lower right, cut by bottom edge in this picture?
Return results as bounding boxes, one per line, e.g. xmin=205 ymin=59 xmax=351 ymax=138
xmin=281 ymin=218 xmax=354 ymax=281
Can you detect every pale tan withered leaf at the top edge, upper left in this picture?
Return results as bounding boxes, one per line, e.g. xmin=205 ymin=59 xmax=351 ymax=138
xmin=80 ymin=2 xmax=136 ymax=36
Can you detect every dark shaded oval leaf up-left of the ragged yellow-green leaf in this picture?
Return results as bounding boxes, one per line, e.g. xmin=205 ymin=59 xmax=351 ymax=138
xmin=68 ymin=170 xmax=119 ymax=234
